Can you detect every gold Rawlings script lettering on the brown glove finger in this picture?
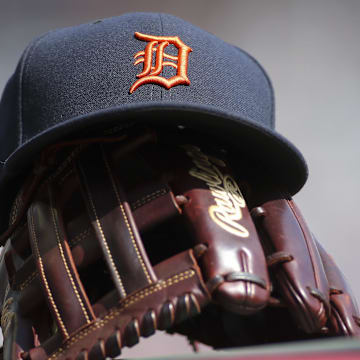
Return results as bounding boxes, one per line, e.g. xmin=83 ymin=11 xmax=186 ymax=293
xmin=183 ymin=145 xmax=249 ymax=238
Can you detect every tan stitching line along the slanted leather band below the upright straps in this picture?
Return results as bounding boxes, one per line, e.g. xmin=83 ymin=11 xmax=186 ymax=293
xmin=49 ymin=269 xmax=195 ymax=359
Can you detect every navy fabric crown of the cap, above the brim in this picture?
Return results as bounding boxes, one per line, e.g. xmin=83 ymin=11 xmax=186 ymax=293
xmin=0 ymin=13 xmax=274 ymax=161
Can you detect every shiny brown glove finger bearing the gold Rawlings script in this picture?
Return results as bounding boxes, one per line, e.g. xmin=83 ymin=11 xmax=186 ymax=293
xmin=164 ymin=145 xmax=270 ymax=314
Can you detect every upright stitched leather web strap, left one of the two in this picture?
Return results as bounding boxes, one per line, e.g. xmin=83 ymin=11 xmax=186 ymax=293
xmin=28 ymin=186 xmax=94 ymax=339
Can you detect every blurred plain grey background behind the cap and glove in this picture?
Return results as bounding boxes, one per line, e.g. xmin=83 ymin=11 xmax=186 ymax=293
xmin=0 ymin=0 xmax=360 ymax=357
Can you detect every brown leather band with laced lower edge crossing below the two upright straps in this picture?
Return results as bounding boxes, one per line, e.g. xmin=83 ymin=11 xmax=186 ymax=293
xmin=29 ymin=252 xmax=209 ymax=360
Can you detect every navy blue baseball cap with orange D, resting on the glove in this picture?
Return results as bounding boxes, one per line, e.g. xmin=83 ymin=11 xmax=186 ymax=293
xmin=0 ymin=13 xmax=307 ymax=230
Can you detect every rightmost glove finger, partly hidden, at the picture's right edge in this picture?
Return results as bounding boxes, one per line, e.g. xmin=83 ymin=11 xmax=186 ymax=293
xmin=315 ymin=240 xmax=360 ymax=336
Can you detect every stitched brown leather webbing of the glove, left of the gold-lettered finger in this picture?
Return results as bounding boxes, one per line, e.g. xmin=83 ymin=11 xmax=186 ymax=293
xmin=2 ymin=130 xmax=214 ymax=359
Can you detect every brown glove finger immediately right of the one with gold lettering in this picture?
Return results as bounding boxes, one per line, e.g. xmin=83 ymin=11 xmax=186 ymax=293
xmin=252 ymin=200 xmax=329 ymax=333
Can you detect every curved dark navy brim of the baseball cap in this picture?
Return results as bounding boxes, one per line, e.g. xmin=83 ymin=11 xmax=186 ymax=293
xmin=0 ymin=102 xmax=308 ymax=231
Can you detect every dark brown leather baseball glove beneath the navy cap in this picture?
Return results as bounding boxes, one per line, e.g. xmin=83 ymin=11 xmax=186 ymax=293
xmin=0 ymin=128 xmax=360 ymax=360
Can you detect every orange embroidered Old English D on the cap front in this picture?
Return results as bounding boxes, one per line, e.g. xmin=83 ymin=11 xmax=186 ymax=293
xmin=130 ymin=32 xmax=192 ymax=94
